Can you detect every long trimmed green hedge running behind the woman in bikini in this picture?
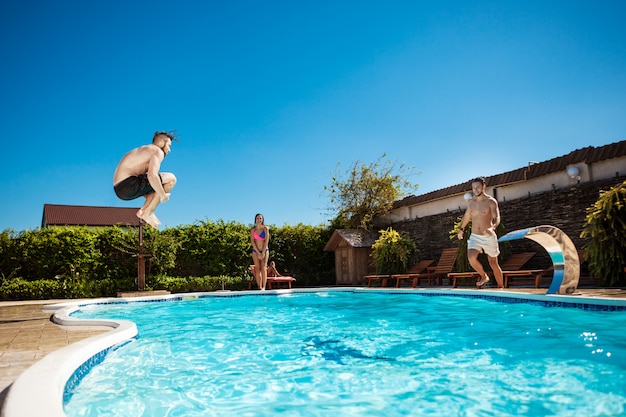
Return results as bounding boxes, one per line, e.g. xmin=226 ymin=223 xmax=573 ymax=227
xmin=0 ymin=220 xmax=335 ymax=300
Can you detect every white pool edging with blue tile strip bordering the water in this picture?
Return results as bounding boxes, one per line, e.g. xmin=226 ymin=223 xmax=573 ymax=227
xmin=1 ymin=287 xmax=626 ymax=417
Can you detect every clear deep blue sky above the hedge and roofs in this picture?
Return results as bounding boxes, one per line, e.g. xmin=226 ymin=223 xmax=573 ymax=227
xmin=0 ymin=0 xmax=626 ymax=231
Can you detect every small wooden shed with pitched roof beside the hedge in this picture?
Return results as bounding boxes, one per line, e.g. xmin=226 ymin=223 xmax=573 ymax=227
xmin=324 ymin=229 xmax=378 ymax=285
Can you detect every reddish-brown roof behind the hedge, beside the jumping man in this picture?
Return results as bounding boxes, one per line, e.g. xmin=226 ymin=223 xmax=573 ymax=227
xmin=41 ymin=204 xmax=139 ymax=228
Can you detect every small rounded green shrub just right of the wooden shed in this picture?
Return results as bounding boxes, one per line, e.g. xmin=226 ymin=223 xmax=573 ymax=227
xmin=372 ymin=227 xmax=417 ymax=274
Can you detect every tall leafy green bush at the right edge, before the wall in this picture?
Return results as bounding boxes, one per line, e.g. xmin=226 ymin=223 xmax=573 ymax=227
xmin=580 ymin=181 xmax=626 ymax=286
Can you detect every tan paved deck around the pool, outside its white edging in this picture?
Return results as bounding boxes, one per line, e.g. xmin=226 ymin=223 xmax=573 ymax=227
xmin=0 ymin=288 xmax=626 ymax=409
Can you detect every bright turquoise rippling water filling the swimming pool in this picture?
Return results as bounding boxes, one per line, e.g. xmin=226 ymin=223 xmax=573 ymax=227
xmin=65 ymin=292 xmax=626 ymax=417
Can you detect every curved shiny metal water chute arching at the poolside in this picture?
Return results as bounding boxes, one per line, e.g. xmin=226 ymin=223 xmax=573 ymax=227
xmin=498 ymin=225 xmax=580 ymax=295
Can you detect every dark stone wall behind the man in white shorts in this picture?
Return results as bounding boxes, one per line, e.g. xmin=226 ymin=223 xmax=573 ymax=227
xmin=391 ymin=176 xmax=626 ymax=268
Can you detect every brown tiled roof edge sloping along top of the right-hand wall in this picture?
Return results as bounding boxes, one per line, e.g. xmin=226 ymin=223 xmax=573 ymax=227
xmin=393 ymin=140 xmax=626 ymax=209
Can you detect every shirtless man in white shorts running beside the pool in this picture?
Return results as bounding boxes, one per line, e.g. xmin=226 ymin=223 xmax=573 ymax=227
xmin=457 ymin=177 xmax=504 ymax=288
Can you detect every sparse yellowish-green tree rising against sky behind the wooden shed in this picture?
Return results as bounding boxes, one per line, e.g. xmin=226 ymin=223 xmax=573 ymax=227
xmin=324 ymin=154 xmax=418 ymax=230
